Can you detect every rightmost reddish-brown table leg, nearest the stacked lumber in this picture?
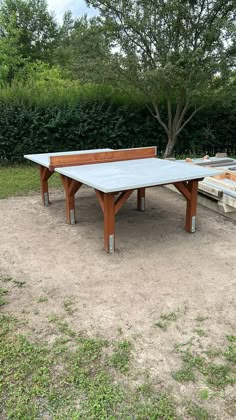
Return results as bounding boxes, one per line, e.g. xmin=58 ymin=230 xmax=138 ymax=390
xmin=185 ymin=180 xmax=198 ymax=233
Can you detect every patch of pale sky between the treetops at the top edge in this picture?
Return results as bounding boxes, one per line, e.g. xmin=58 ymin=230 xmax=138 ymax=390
xmin=48 ymin=0 xmax=97 ymax=22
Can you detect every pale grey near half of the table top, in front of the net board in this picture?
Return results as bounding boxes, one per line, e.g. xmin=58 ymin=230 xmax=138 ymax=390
xmin=55 ymin=158 xmax=222 ymax=193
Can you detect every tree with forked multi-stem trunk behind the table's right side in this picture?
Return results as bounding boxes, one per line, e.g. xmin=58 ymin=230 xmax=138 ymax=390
xmin=87 ymin=0 xmax=235 ymax=157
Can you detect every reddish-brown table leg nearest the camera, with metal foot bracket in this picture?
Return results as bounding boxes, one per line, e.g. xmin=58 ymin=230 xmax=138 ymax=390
xmin=104 ymin=193 xmax=115 ymax=254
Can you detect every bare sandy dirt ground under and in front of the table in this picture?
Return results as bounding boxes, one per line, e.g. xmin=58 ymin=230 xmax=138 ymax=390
xmin=0 ymin=187 xmax=236 ymax=419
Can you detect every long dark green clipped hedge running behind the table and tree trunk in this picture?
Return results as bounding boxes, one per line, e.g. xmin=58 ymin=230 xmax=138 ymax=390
xmin=0 ymin=84 xmax=236 ymax=163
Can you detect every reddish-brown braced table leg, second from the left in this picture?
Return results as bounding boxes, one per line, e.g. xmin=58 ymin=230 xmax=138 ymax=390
xmin=61 ymin=175 xmax=82 ymax=225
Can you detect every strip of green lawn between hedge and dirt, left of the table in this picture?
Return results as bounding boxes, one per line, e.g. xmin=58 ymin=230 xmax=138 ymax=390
xmin=0 ymin=165 xmax=61 ymax=199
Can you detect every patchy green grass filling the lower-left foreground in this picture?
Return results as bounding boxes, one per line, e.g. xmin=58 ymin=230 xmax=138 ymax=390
xmin=0 ymin=315 xmax=177 ymax=420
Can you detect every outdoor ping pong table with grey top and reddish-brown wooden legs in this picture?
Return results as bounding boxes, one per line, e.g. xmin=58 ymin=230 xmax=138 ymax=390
xmin=25 ymin=146 xmax=220 ymax=253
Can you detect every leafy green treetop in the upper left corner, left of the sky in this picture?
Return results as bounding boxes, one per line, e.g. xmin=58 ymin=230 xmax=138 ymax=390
xmin=0 ymin=0 xmax=58 ymax=63
